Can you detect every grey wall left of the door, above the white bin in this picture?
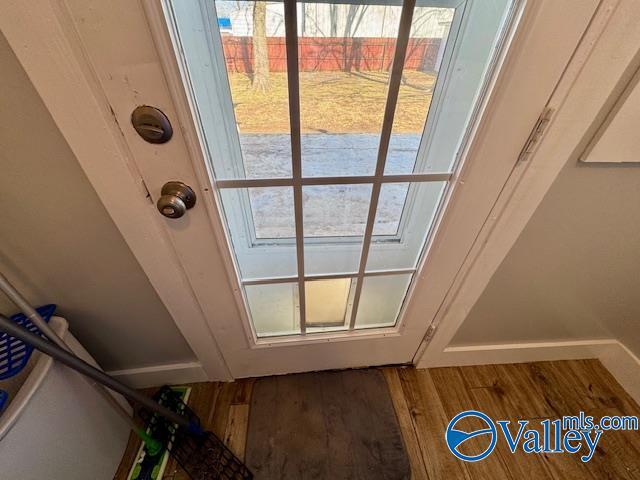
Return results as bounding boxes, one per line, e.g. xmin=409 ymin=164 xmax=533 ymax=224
xmin=0 ymin=35 xmax=195 ymax=370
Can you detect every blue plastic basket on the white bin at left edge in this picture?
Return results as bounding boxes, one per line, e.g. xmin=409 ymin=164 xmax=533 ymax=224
xmin=0 ymin=305 xmax=56 ymax=380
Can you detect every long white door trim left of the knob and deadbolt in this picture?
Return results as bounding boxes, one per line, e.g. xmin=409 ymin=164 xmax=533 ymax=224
xmin=0 ymin=0 xmax=231 ymax=380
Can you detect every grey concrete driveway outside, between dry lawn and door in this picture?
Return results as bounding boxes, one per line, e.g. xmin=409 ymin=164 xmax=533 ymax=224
xmin=241 ymin=133 xmax=420 ymax=238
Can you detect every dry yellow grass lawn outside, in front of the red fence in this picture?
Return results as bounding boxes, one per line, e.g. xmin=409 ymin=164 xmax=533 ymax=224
xmin=229 ymin=71 xmax=435 ymax=133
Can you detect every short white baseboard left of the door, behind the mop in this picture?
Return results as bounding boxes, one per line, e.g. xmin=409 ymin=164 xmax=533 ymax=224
xmin=107 ymin=362 xmax=208 ymax=388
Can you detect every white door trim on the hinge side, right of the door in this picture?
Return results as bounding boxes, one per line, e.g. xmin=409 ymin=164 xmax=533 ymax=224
xmin=414 ymin=0 xmax=640 ymax=368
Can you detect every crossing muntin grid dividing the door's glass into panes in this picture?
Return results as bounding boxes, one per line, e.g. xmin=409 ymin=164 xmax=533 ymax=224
xmin=215 ymin=0 xmax=453 ymax=338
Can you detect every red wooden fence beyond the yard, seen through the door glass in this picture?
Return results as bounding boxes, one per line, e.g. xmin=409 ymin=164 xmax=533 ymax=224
xmin=222 ymin=35 xmax=440 ymax=73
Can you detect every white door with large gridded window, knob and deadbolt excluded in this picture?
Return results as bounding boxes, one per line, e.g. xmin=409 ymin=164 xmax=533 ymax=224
xmin=31 ymin=0 xmax=598 ymax=377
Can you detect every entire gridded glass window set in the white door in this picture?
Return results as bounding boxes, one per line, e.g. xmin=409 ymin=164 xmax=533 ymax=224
xmin=167 ymin=0 xmax=513 ymax=338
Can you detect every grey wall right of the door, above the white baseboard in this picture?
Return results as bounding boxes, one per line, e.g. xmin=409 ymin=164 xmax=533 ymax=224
xmin=452 ymin=158 xmax=640 ymax=355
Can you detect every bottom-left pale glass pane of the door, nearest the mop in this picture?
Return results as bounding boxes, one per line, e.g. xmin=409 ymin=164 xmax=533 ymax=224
xmin=244 ymin=283 xmax=300 ymax=337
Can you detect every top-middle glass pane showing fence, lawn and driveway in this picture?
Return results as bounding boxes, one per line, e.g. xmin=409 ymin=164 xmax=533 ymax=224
xmin=298 ymin=1 xmax=401 ymax=177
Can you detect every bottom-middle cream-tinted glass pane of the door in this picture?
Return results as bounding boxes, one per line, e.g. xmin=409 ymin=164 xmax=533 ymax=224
xmin=304 ymin=278 xmax=351 ymax=327
